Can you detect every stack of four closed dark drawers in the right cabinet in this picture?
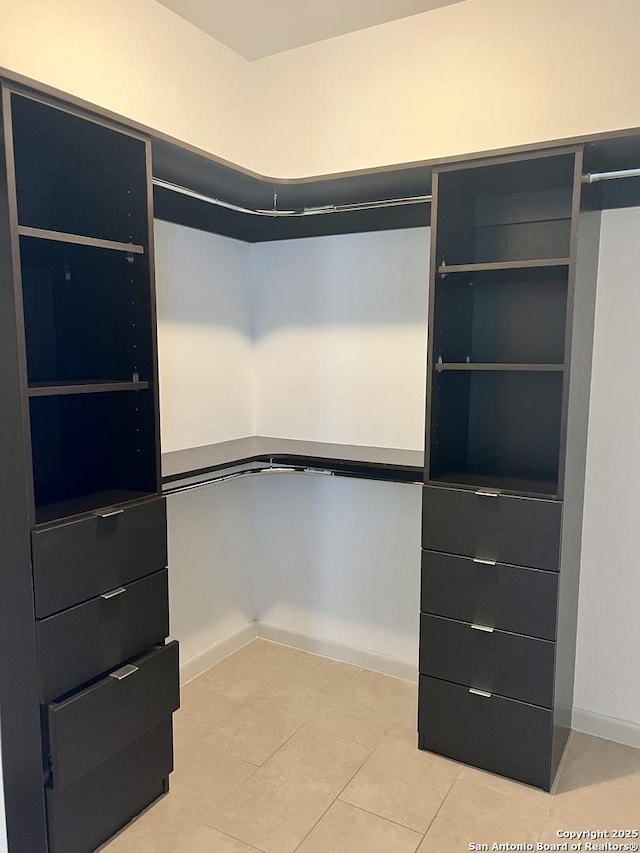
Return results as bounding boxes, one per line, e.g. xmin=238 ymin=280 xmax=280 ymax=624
xmin=418 ymin=486 xmax=562 ymax=788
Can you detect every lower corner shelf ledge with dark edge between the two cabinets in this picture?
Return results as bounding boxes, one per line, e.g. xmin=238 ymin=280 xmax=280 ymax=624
xmin=162 ymin=436 xmax=424 ymax=489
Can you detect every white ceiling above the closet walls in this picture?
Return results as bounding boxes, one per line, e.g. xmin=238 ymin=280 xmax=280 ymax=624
xmin=158 ymin=0 xmax=462 ymax=60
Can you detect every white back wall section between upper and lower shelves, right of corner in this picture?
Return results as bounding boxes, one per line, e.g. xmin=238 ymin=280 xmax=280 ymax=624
xmin=252 ymin=228 xmax=429 ymax=449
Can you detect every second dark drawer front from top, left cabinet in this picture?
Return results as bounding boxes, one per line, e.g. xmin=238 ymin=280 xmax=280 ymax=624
xmin=36 ymin=569 xmax=169 ymax=703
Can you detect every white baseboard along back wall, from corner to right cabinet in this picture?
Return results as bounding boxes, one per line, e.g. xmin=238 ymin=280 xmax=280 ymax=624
xmin=256 ymin=622 xmax=418 ymax=682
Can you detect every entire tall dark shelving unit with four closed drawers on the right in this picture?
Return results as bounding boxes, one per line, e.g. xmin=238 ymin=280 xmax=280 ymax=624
xmin=418 ymin=146 xmax=599 ymax=790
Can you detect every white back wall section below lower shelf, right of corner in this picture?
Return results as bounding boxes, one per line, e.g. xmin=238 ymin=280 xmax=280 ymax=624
xmin=252 ymin=474 xmax=421 ymax=674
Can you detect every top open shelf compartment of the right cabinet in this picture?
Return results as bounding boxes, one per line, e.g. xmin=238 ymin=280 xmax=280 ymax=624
xmin=436 ymin=154 xmax=574 ymax=268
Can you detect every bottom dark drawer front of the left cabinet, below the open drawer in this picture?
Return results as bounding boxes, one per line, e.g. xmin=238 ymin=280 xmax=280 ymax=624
xmin=47 ymin=718 xmax=173 ymax=853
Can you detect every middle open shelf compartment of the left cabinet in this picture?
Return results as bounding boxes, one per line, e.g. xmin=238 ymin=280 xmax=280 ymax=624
xmin=20 ymin=237 xmax=154 ymax=386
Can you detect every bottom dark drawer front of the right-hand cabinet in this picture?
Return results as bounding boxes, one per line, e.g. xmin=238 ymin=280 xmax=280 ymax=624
xmin=418 ymin=675 xmax=552 ymax=791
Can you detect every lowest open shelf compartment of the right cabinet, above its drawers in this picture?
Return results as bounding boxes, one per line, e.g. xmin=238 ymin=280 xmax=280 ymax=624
xmin=428 ymin=371 xmax=563 ymax=496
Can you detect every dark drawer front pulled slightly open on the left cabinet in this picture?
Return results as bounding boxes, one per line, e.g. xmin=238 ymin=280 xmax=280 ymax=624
xmin=49 ymin=642 xmax=180 ymax=788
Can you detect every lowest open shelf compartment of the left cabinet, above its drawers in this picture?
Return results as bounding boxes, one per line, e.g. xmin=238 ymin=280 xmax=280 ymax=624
xmin=29 ymin=390 xmax=157 ymax=523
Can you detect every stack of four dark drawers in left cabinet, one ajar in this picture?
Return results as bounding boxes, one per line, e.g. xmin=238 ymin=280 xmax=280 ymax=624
xmin=32 ymin=498 xmax=179 ymax=853
